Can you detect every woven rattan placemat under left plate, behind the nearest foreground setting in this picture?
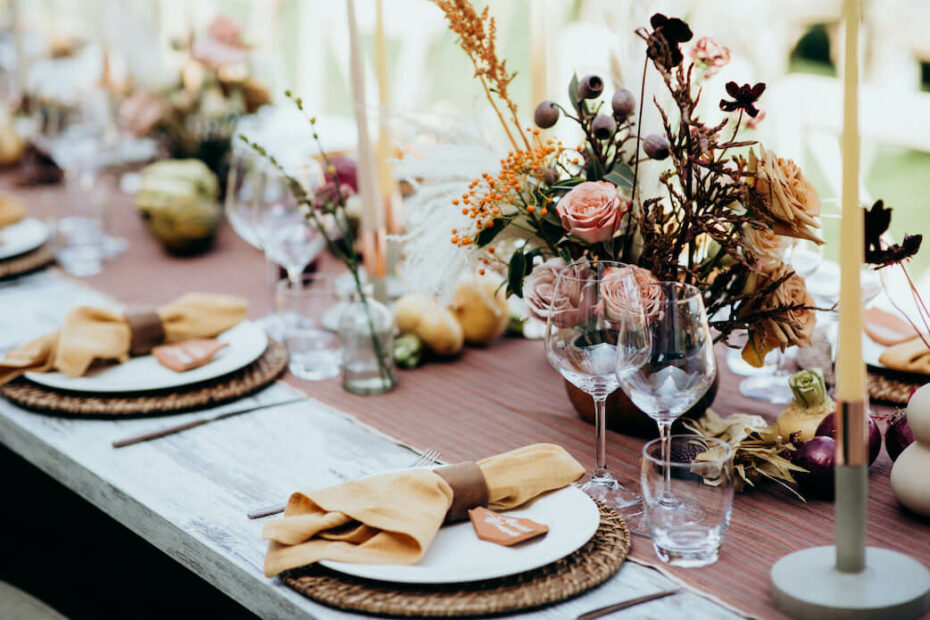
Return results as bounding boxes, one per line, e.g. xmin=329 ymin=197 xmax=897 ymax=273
xmin=0 ymin=340 xmax=287 ymax=418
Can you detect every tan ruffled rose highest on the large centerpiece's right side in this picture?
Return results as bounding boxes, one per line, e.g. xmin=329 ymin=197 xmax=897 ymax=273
xmin=749 ymin=147 xmax=823 ymax=243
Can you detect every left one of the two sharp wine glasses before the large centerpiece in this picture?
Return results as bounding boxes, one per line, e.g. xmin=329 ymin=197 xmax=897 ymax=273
xmin=545 ymin=259 xmax=640 ymax=509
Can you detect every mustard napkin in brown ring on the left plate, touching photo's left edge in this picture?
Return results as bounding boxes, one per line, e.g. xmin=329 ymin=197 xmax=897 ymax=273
xmin=0 ymin=293 xmax=248 ymax=385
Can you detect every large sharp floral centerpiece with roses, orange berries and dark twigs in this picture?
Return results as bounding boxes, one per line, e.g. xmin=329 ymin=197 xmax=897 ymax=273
xmin=424 ymin=0 xmax=820 ymax=365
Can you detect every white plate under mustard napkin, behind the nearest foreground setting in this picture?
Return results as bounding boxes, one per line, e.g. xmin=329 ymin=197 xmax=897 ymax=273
xmin=26 ymin=321 xmax=268 ymax=393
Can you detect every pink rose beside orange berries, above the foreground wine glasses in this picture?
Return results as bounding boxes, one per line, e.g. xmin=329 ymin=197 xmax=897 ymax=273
xmin=555 ymin=181 xmax=626 ymax=243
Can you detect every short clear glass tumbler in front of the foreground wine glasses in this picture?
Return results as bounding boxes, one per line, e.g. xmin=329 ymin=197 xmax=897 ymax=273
xmin=640 ymin=435 xmax=733 ymax=567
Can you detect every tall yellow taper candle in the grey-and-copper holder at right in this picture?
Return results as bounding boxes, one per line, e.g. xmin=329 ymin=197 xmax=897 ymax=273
xmin=836 ymin=0 xmax=866 ymax=402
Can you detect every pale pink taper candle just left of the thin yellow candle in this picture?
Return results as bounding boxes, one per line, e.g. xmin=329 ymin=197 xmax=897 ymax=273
xmin=346 ymin=0 xmax=384 ymax=231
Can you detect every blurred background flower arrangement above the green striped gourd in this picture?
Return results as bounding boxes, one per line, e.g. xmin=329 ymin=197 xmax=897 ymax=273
xmin=120 ymin=17 xmax=271 ymax=173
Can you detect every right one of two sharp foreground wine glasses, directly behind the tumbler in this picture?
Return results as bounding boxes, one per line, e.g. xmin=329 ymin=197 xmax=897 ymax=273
xmin=616 ymin=282 xmax=717 ymax=519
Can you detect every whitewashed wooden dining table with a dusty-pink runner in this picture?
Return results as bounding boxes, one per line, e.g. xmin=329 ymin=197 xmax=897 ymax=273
xmin=0 ymin=175 xmax=930 ymax=618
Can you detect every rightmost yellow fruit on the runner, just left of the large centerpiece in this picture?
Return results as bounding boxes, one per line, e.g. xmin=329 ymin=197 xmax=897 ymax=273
xmin=449 ymin=274 xmax=510 ymax=345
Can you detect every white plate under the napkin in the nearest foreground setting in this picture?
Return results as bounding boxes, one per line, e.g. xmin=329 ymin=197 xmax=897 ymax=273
xmin=320 ymin=486 xmax=600 ymax=583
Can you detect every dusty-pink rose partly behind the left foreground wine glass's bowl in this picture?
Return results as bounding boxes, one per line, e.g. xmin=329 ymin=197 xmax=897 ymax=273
xmin=523 ymin=258 xmax=594 ymax=327
